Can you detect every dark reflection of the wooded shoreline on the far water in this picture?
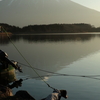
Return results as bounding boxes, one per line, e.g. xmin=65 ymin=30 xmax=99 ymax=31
xmin=0 ymin=34 xmax=100 ymax=44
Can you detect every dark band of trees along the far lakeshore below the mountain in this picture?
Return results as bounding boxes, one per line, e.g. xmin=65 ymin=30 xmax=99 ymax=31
xmin=0 ymin=23 xmax=100 ymax=33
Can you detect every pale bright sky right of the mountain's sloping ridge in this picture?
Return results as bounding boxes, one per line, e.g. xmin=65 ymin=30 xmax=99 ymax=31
xmin=71 ymin=0 xmax=100 ymax=11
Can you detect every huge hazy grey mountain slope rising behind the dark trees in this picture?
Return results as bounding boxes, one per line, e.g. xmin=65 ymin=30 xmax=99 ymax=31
xmin=0 ymin=0 xmax=100 ymax=26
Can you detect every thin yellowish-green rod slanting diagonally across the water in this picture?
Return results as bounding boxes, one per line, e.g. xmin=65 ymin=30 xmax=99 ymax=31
xmin=1 ymin=26 xmax=50 ymax=87
